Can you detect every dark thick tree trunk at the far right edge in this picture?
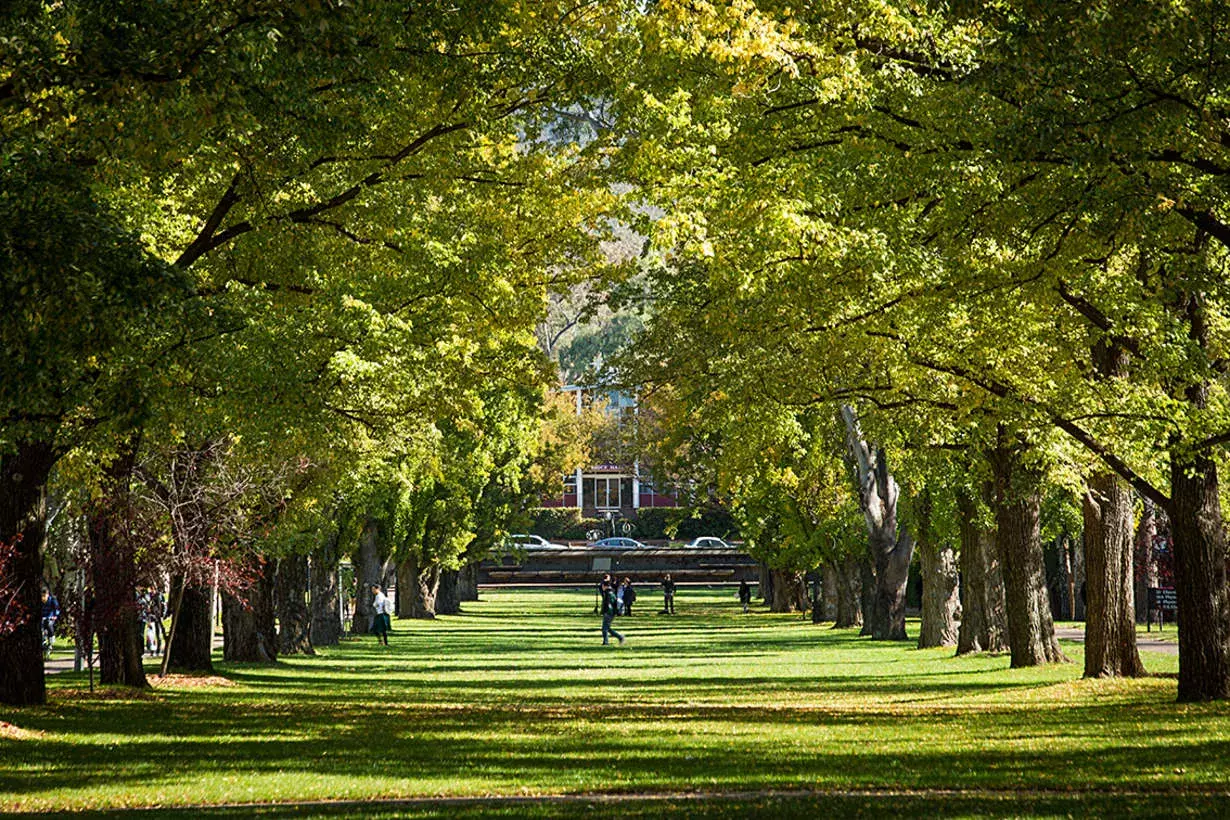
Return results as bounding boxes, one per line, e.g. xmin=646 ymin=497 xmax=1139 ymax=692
xmin=1167 ymin=445 xmax=1230 ymax=702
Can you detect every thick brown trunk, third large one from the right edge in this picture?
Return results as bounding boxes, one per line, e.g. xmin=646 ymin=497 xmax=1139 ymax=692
xmin=990 ymin=433 xmax=1068 ymax=668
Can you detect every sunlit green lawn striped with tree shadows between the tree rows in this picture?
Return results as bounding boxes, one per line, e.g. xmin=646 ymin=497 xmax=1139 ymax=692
xmin=0 ymin=589 xmax=1230 ymax=818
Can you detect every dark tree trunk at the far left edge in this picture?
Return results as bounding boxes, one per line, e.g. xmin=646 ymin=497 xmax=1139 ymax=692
xmin=0 ymin=441 xmax=55 ymax=706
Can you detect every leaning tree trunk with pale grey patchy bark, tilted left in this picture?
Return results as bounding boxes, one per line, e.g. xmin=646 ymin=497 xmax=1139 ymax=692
xmin=841 ymin=406 xmax=914 ymax=641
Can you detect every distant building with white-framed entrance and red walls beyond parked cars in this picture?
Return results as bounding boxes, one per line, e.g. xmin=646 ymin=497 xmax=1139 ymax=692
xmin=542 ymin=385 xmax=679 ymax=518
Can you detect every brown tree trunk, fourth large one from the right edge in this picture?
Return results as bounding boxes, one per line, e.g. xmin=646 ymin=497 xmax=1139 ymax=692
xmin=957 ymin=492 xmax=1007 ymax=655
